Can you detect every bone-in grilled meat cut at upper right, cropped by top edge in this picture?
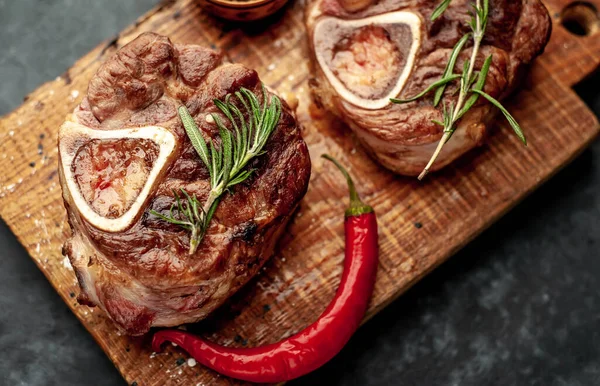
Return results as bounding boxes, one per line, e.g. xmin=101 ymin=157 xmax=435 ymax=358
xmin=306 ymin=0 xmax=551 ymax=175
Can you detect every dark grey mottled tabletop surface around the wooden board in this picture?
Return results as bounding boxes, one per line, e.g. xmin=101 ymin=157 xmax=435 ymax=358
xmin=0 ymin=0 xmax=600 ymax=386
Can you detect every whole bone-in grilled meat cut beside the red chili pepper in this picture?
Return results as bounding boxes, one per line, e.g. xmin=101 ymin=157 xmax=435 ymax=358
xmin=59 ymin=33 xmax=310 ymax=335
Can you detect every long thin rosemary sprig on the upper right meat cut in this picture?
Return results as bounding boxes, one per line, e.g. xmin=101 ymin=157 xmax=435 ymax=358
xmin=391 ymin=0 xmax=527 ymax=180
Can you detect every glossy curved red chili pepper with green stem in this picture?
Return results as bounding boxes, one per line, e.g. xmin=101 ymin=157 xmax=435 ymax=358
xmin=152 ymin=155 xmax=378 ymax=383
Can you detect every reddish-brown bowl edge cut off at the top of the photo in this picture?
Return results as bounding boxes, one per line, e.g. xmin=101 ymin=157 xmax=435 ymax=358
xmin=199 ymin=0 xmax=287 ymax=21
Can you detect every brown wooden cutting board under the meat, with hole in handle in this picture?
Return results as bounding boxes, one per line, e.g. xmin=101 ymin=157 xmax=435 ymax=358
xmin=0 ymin=0 xmax=600 ymax=386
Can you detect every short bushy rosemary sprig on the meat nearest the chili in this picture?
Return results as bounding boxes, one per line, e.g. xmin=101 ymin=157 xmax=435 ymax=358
xmin=150 ymin=86 xmax=281 ymax=254
